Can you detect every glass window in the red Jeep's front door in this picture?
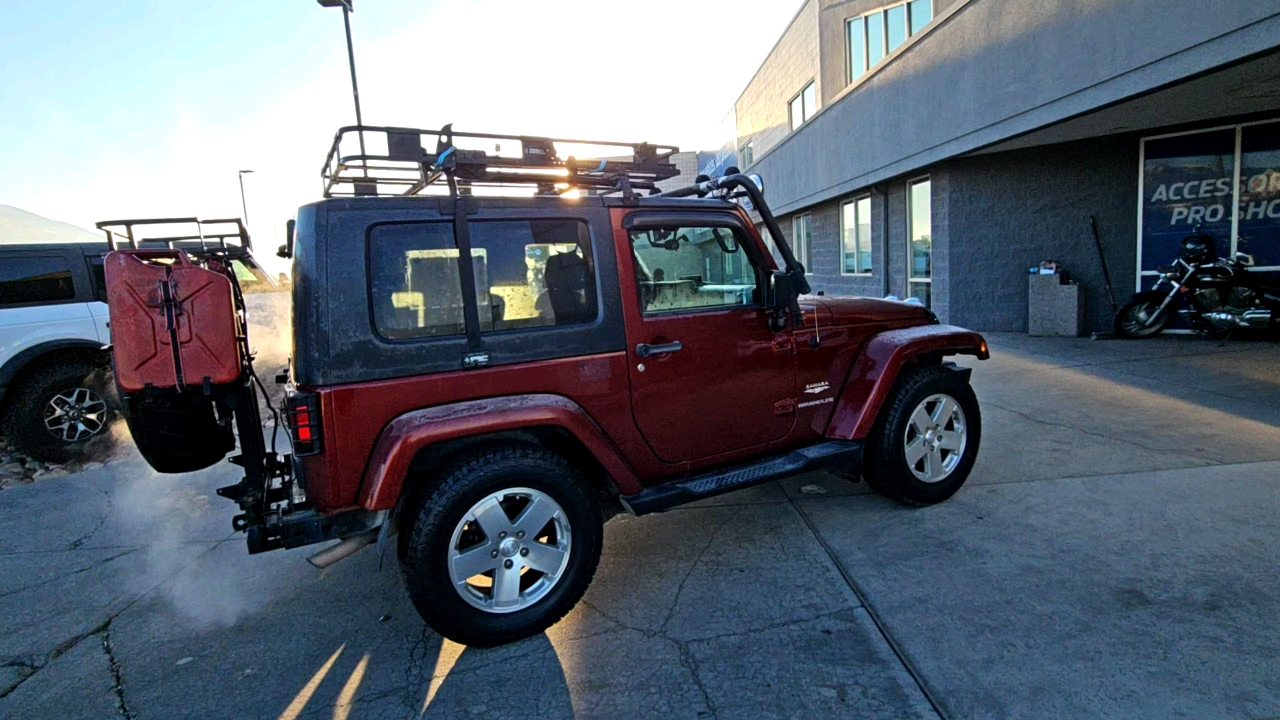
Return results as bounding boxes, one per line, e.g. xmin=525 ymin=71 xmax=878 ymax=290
xmin=631 ymin=227 xmax=756 ymax=315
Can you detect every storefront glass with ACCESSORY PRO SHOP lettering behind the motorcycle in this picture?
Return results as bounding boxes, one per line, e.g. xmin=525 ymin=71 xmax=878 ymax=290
xmin=1138 ymin=122 xmax=1280 ymax=287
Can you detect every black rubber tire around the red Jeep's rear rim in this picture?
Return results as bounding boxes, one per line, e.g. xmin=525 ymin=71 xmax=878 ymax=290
xmin=399 ymin=445 xmax=604 ymax=647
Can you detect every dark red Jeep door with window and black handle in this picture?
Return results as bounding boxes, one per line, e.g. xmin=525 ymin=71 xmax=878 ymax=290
xmin=614 ymin=210 xmax=795 ymax=462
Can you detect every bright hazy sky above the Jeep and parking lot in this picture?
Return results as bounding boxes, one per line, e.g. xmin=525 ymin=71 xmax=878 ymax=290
xmin=0 ymin=0 xmax=800 ymax=269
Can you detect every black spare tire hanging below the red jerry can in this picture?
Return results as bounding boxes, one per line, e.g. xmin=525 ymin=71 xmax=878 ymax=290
xmin=124 ymin=392 xmax=236 ymax=473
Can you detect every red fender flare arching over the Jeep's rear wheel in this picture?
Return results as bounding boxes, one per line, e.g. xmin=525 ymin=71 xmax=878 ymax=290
xmin=357 ymin=393 xmax=641 ymax=510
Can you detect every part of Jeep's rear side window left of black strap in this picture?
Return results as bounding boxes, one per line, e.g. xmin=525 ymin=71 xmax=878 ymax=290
xmin=369 ymin=223 xmax=471 ymax=340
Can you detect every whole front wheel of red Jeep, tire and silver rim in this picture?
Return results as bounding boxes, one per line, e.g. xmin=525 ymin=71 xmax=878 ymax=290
xmin=863 ymin=365 xmax=982 ymax=506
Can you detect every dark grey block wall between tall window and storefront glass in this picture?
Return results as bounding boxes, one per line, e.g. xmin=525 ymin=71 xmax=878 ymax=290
xmin=934 ymin=135 xmax=1138 ymax=332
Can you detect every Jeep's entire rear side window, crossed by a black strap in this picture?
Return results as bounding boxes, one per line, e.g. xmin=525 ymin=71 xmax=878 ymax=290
xmin=369 ymin=220 xmax=596 ymax=340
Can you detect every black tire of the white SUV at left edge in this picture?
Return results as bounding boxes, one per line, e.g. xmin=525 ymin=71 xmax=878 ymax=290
xmin=0 ymin=360 xmax=118 ymax=462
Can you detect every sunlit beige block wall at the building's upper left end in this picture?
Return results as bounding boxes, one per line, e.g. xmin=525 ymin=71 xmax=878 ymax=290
xmin=735 ymin=0 xmax=823 ymax=163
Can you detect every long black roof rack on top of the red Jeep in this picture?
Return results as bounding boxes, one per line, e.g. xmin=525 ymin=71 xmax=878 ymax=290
xmin=320 ymin=124 xmax=680 ymax=197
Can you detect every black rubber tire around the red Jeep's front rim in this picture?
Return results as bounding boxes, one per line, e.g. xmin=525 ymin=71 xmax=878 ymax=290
xmin=863 ymin=365 xmax=982 ymax=506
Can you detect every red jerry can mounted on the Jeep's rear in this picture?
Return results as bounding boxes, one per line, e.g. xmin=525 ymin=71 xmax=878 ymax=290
xmin=105 ymin=250 xmax=243 ymax=393
